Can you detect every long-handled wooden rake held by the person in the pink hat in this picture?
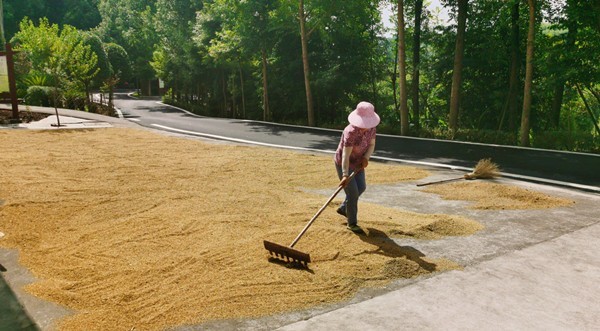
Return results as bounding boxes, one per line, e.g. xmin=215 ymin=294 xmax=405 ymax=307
xmin=263 ymin=169 xmax=361 ymax=267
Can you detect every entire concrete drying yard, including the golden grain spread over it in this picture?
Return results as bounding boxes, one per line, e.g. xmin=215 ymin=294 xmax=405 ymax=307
xmin=0 ymin=113 xmax=600 ymax=330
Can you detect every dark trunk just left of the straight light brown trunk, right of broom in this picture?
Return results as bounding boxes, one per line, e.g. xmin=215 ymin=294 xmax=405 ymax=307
xmin=498 ymin=0 xmax=521 ymax=132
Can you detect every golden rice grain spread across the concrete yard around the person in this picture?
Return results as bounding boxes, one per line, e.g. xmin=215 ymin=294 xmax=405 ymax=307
xmin=0 ymin=128 xmax=572 ymax=330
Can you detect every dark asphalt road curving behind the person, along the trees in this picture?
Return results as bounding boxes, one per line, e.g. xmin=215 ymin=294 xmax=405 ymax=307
xmin=115 ymin=94 xmax=600 ymax=193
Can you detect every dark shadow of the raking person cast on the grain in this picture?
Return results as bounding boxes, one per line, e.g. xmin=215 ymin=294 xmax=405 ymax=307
xmin=358 ymin=228 xmax=437 ymax=272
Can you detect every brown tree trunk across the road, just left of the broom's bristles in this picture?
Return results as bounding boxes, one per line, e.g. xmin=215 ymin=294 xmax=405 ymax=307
xmin=449 ymin=0 xmax=468 ymax=136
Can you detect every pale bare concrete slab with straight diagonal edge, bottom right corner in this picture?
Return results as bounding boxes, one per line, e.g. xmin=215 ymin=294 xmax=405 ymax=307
xmin=279 ymin=224 xmax=600 ymax=331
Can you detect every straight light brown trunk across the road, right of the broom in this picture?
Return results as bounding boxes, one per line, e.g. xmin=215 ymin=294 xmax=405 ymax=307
xmin=520 ymin=0 xmax=535 ymax=147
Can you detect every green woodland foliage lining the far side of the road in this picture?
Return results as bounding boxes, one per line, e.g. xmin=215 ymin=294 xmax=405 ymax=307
xmin=4 ymin=0 xmax=600 ymax=151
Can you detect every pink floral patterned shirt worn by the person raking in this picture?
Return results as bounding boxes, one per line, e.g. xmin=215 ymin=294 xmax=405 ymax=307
xmin=334 ymin=124 xmax=376 ymax=170
